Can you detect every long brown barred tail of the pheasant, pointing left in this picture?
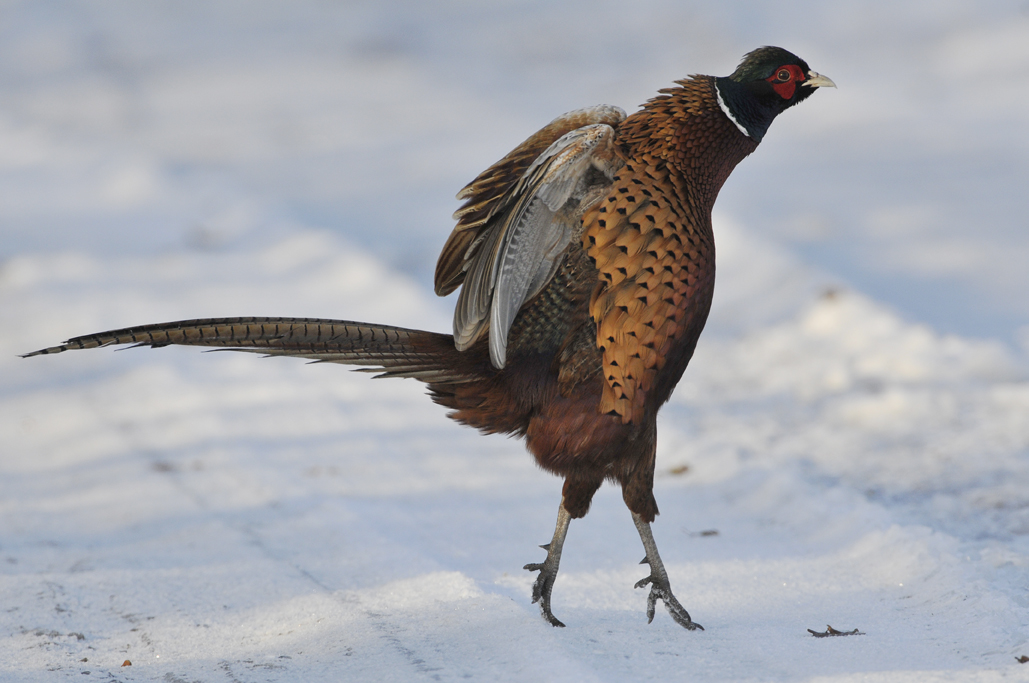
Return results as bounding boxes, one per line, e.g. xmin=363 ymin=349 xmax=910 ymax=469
xmin=23 ymin=318 xmax=489 ymax=384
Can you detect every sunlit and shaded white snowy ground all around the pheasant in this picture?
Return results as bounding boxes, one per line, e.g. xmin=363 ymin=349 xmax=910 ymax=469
xmin=0 ymin=0 xmax=1029 ymax=682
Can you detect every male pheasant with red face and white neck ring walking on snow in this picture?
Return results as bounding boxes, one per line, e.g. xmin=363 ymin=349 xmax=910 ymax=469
xmin=27 ymin=47 xmax=835 ymax=630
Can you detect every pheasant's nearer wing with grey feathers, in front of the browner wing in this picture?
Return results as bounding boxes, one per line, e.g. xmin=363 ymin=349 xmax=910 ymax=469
xmin=454 ymin=123 xmax=622 ymax=368
